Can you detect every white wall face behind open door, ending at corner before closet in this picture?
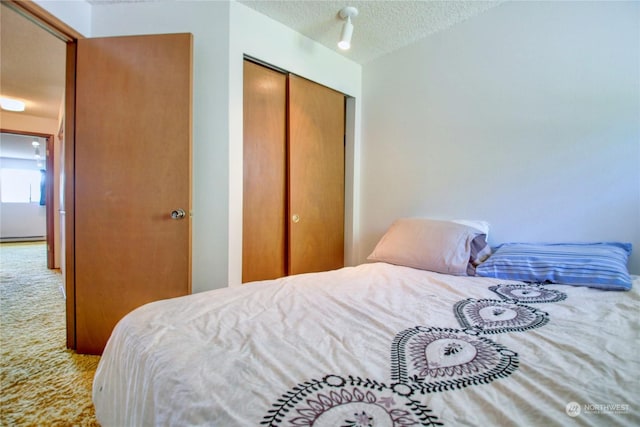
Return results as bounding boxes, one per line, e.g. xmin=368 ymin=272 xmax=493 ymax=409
xmin=91 ymin=1 xmax=229 ymax=292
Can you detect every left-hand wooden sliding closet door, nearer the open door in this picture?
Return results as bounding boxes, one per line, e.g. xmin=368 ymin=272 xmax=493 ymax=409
xmin=242 ymin=61 xmax=287 ymax=282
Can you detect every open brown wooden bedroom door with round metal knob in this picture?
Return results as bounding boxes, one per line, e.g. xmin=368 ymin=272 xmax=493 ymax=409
xmin=68 ymin=34 xmax=192 ymax=354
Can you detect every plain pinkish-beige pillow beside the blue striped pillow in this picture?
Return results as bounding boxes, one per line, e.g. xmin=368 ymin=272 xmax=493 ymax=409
xmin=367 ymin=218 xmax=490 ymax=276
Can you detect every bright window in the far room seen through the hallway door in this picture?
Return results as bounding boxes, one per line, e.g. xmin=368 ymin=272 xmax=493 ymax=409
xmin=0 ymin=168 xmax=45 ymax=205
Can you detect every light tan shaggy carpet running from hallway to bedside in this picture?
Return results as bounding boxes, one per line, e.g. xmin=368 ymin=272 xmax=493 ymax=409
xmin=0 ymin=243 xmax=100 ymax=426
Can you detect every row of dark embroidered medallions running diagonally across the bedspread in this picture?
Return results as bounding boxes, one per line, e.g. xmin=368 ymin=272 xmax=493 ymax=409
xmin=260 ymin=284 xmax=567 ymax=427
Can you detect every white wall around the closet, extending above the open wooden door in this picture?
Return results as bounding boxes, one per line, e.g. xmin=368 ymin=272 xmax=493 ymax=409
xmin=79 ymin=1 xmax=361 ymax=292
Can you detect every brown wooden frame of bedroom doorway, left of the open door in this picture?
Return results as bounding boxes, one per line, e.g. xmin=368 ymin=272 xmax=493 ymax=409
xmin=3 ymin=0 xmax=84 ymax=349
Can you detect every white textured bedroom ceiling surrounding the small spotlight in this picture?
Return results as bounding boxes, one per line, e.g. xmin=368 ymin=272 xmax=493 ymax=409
xmin=238 ymin=0 xmax=502 ymax=64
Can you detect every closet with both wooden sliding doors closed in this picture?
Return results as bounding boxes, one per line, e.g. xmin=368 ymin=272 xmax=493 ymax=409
xmin=242 ymin=60 xmax=345 ymax=282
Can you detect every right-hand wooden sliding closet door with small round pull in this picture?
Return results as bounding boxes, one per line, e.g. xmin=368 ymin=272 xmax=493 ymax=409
xmin=288 ymin=75 xmax=344 ymax=274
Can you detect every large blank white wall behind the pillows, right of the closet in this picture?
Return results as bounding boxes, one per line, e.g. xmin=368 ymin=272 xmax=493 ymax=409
xmin=360 ymin=2 xmax=640 ymax=274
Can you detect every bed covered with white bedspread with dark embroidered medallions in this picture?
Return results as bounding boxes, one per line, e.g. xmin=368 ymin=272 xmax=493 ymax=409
xmin=93 ymin=219 xmax=640 ymax=427
